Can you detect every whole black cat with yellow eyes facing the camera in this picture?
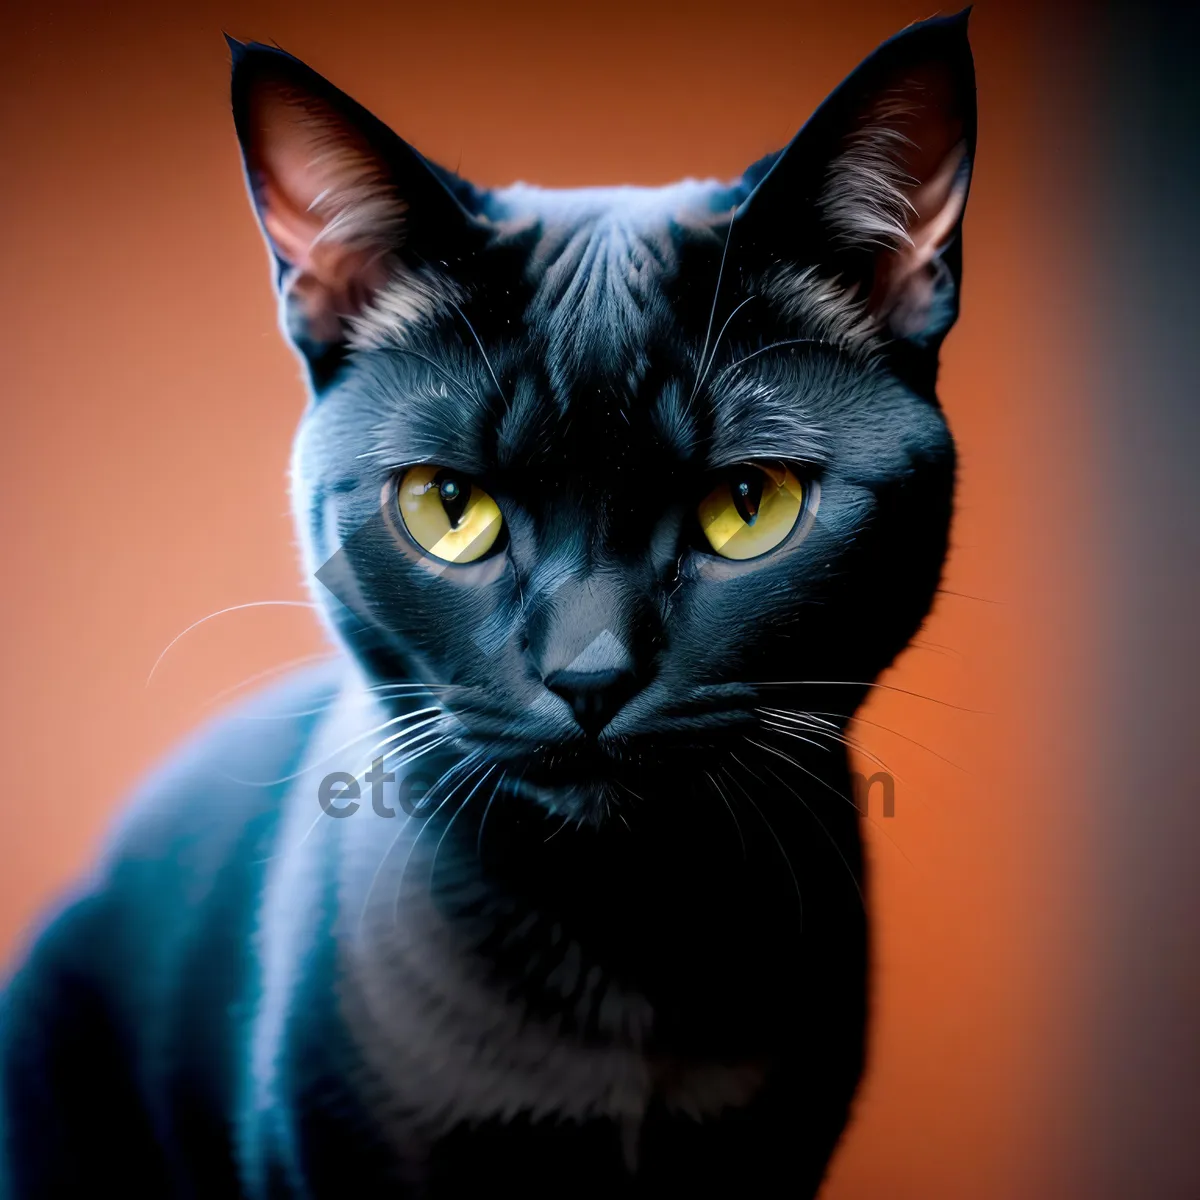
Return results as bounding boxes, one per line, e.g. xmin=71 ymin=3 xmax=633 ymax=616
xmin=0 ymin=12 xmax=976 ymax=1200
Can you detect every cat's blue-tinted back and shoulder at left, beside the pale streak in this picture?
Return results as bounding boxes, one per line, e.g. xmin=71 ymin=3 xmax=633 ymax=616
xmin=0 ymin=670 xmax=352 ymax=1195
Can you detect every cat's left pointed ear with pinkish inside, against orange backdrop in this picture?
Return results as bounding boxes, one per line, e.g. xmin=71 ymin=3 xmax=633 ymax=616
xmin=227 ymin=38 xmax=474 ymax=380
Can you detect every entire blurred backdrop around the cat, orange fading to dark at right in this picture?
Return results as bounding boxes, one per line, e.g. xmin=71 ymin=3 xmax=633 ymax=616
xmin=0 ymin=0 xmax=1200 ymax=1200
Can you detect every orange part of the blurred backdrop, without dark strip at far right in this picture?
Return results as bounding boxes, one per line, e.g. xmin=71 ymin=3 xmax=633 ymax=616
xmin=0 ymin=0 xmax=1098 ymax=1200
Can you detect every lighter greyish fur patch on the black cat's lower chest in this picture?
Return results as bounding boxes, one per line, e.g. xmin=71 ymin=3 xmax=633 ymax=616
xmin=341 ymin=883 xmax=766 ymax=1157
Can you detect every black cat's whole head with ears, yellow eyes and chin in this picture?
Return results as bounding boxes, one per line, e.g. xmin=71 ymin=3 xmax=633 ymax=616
xmin=226 ymin=14 xmax=976 ymax=814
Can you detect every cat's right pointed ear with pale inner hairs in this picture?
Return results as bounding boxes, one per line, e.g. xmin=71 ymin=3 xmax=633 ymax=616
xmin=737 ymin=10 xmax=976 ymax=348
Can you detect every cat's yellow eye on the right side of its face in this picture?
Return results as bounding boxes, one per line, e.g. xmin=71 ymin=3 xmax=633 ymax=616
xmin=698 ymin=463 xmax=804 ymax=558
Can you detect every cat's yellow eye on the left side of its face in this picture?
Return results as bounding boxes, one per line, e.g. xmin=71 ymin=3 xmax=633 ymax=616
xmin=396 ymin=467 xmax=504 ymax=563
